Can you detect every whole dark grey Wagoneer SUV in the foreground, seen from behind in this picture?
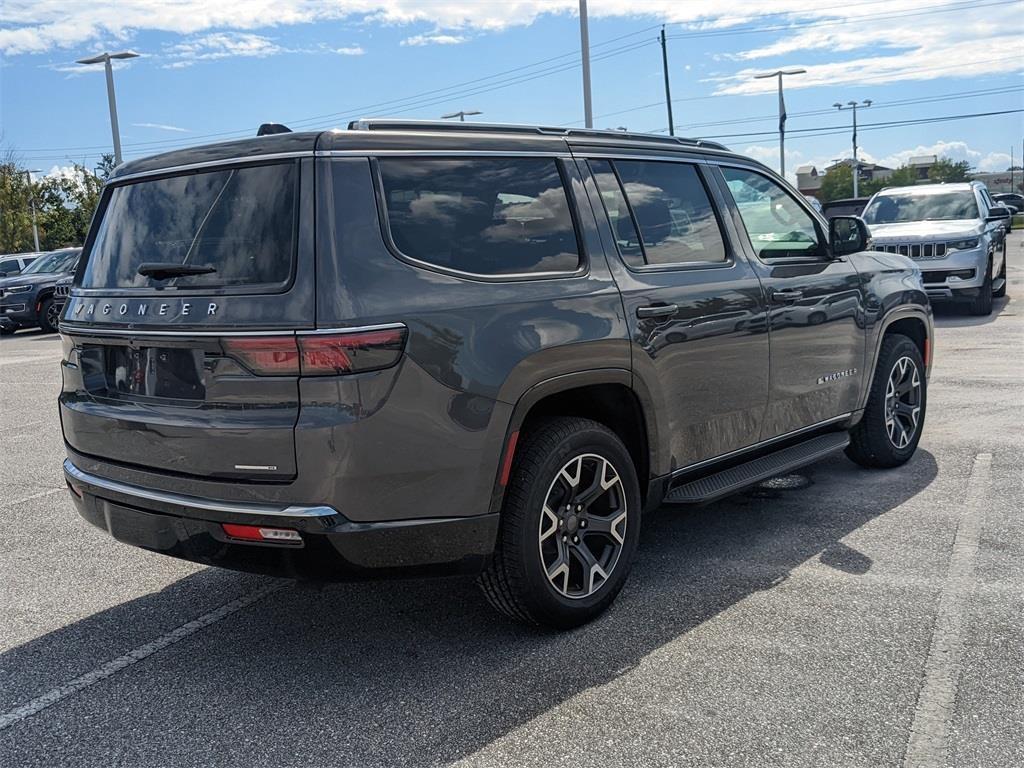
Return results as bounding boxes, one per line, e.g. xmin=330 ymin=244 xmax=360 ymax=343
xmin=59 ymin=121 xmax=932 ymax=627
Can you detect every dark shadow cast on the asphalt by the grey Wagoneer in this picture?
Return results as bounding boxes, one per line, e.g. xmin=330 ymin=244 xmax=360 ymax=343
xmin=0 ymin=451 xmax=937 ymax=768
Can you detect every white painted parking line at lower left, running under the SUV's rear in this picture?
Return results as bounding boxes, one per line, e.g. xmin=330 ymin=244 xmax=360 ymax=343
xmin=0 ymin=581 xmax=288 ymax=731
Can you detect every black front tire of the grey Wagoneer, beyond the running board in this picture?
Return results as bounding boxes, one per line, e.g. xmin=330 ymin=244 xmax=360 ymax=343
xmin=846 ymin=334 xmax=928 ymax=468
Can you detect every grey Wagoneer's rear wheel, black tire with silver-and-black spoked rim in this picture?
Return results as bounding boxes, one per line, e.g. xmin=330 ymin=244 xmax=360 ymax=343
xmin=478 ymin=418 xmax=641 ymax=629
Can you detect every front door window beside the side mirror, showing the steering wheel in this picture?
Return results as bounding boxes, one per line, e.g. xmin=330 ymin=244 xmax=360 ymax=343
xmin=722 ymin=168 xmax=822 ymax=259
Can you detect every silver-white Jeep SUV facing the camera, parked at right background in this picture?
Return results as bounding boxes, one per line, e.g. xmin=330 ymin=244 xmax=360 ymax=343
xmin=864 ymin=181 xmax=1009 ymax=315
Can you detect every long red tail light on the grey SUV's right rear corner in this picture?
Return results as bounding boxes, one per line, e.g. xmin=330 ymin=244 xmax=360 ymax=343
xmin=223 ymin=326 xmax=407 ymax=376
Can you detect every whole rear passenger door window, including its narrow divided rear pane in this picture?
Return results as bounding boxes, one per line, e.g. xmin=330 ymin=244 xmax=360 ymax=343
xmin=591 ymin=160 xmax=726 ymax=266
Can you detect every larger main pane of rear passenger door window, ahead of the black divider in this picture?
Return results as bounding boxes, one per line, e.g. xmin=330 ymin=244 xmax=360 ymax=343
xmin=614 ymin=160 xmax=725 ymax=264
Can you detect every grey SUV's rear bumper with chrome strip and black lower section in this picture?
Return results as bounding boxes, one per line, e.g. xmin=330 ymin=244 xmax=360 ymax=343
xmin=63 ymin=461 xmax=498 ymax=581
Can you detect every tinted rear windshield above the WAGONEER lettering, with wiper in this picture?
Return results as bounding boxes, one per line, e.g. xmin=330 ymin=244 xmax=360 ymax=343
xmin=82 ymin=163 xmax=298 ymax=289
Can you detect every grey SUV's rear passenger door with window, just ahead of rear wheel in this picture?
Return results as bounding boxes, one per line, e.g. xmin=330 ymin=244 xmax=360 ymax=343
xmin=589 ymin=158 xmax=768 ymax=470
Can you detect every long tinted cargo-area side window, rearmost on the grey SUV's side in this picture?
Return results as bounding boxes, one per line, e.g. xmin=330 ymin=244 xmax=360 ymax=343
xmin=378 ymin=158 xmax=580 ymax=275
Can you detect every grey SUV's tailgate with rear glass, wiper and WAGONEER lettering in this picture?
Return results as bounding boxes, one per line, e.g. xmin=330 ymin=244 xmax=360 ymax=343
xmin=60 ymin=159 xmax=315 ymax=481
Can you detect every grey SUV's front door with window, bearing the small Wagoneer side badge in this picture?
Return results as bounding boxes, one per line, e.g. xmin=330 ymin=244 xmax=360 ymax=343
xmin=718 ymin=166 xmax=865 ymax=439
